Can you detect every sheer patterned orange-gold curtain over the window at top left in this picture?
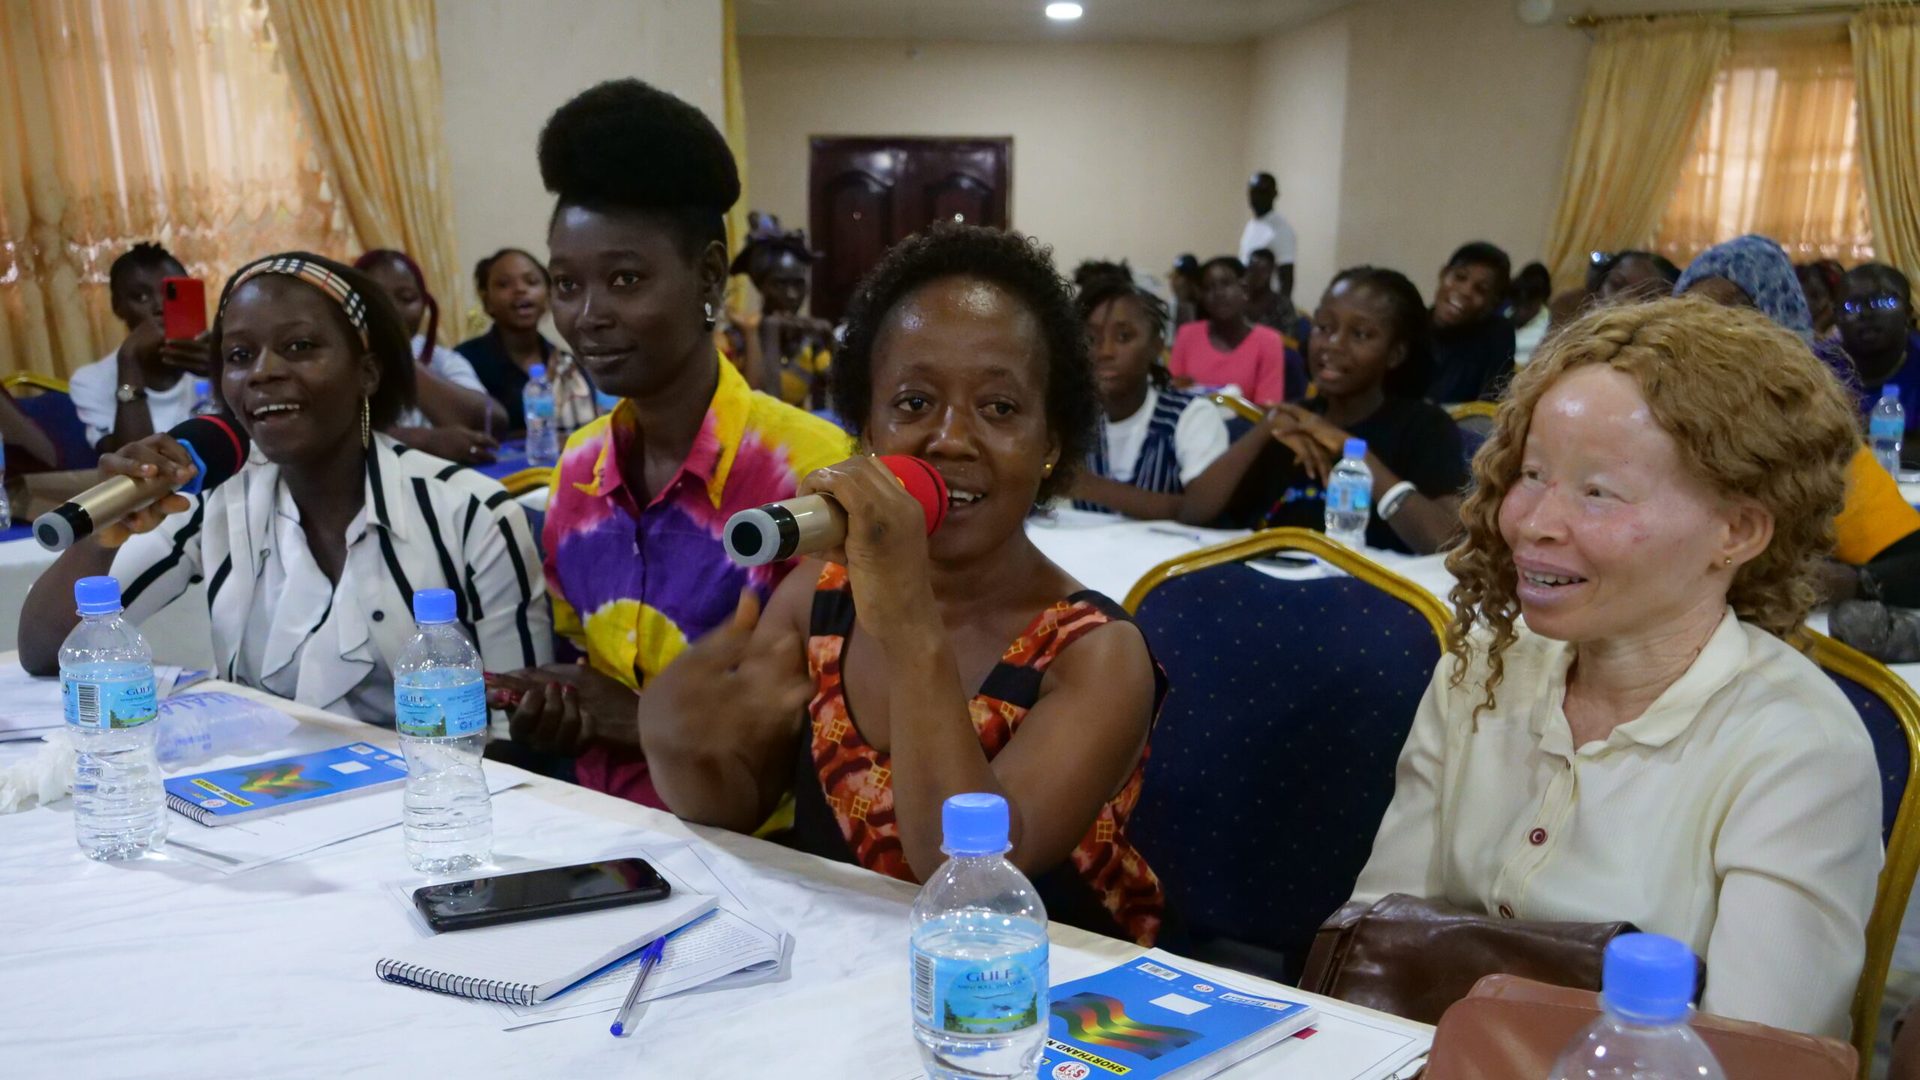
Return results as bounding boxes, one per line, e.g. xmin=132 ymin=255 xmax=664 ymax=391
xmin=0 ymin=0 xmax=353 ymax=377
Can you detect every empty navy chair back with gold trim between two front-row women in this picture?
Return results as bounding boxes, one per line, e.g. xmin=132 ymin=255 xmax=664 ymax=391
xmin=1127 ymin=528 xmax=1446 ymax=980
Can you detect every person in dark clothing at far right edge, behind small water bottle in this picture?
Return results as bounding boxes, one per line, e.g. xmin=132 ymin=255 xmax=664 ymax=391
xmin=1837 ymin=263 xmax=1920 ymax=449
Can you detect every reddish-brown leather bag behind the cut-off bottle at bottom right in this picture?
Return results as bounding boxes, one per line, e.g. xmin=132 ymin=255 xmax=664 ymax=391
xmin=1421 ymin=974 xmax=1859 ymax=1080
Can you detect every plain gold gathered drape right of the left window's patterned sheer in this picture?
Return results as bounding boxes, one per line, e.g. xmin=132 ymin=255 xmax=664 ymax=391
xmin=267 ymin=0 xmax=462 ymax=344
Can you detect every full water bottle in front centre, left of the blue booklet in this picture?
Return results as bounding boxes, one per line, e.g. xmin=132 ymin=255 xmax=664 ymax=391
xmin=910 ymin=794 xmax=1048 ymax=1080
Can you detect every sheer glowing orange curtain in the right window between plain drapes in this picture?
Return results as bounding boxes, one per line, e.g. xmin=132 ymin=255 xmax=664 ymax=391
xmin=1653 ymin=27 xmax=1874 ymax=265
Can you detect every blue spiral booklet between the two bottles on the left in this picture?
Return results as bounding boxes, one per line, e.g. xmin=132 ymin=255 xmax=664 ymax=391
xmin=167 ymin=742 xmax=407 ymax=824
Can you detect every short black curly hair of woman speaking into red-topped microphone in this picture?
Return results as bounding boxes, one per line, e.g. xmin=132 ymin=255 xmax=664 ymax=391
xmin=831 ymin=221 xmax=1100 ymax=502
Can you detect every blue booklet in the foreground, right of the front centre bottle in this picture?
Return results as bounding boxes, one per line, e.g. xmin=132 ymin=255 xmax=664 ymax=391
xmin=1039 ymin=953 xmax=1313 ymax=1080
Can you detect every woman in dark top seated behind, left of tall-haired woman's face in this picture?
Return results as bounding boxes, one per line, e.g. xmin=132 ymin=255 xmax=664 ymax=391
xmin=457 ymin=248 xmax=599 ymax=432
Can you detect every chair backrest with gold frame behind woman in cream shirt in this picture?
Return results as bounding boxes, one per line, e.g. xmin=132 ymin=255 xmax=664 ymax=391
xmin=1801 ymin=630 xmax=1920 ymax=1076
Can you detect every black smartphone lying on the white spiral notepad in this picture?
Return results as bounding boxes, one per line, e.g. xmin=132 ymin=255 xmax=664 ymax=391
xmin=413 ymin=859 xmax=672 ymax=932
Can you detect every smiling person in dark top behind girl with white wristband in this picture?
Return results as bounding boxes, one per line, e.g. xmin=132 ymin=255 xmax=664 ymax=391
xmin=1427 ymin=240 xmax=1513 ymax=405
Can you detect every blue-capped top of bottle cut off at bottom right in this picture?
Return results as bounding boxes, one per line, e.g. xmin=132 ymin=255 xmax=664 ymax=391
xmin=1548 ymin=934 xmax=1726 ymax=1080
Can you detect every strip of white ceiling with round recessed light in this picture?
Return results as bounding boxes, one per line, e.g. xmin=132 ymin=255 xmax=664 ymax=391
xmin=735 ymin=0 xmax=1357 ymax=42
